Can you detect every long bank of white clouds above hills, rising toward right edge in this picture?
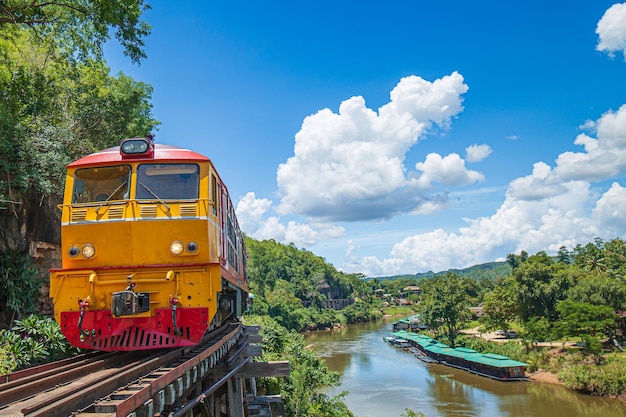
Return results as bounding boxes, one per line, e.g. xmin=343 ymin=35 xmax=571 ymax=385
xmin=345 ymin=106 xmax=626 ymax=275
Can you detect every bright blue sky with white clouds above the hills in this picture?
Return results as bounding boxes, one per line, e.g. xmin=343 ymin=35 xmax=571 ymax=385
xmin=105 ymin=0 xmax=626 ymax=276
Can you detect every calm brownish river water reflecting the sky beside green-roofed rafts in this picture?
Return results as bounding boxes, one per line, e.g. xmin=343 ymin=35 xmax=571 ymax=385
xmin=306 ymin=321 xmax=626 ymax=417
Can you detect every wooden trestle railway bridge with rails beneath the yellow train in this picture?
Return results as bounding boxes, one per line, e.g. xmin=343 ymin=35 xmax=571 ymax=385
xmin=0 ymin=323 xmax=289 ymax=417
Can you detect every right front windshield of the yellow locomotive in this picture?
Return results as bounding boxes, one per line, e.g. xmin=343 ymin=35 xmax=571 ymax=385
xmin=137 ymin=164 xmax=200 ymax=200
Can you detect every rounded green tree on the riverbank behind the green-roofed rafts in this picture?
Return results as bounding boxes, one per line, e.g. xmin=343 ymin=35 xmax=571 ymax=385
xmin=418 ymin=272 xmax=471 ymax=347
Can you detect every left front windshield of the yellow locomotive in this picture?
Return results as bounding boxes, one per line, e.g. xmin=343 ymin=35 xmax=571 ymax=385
xmin=72 ymin=165 xmax=130 ymax=203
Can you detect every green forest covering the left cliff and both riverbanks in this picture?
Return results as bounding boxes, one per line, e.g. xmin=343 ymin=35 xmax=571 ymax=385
xmin=0 ymin=0 xmax=626 ymax=416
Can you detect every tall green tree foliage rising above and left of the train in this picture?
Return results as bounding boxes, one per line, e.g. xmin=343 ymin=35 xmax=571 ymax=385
xmin=0 ymin=12 xmax=158 ymax=228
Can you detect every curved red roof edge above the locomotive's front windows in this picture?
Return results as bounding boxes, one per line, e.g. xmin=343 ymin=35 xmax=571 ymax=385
xmin=67 ymin=143 xmax=209 ymax=168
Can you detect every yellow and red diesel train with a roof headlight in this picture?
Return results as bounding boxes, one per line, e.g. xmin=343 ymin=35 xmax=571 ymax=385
xmin=50 ymin=135 xmax=250 ymax=351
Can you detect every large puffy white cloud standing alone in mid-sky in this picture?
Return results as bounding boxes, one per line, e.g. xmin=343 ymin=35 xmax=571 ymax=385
xmin=277 ymin=72 xmax=472 ymax=221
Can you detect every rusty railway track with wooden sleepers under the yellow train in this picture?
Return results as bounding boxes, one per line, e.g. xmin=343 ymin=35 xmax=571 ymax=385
xmin=0 ymin=324 xmax=244 ymax=417
